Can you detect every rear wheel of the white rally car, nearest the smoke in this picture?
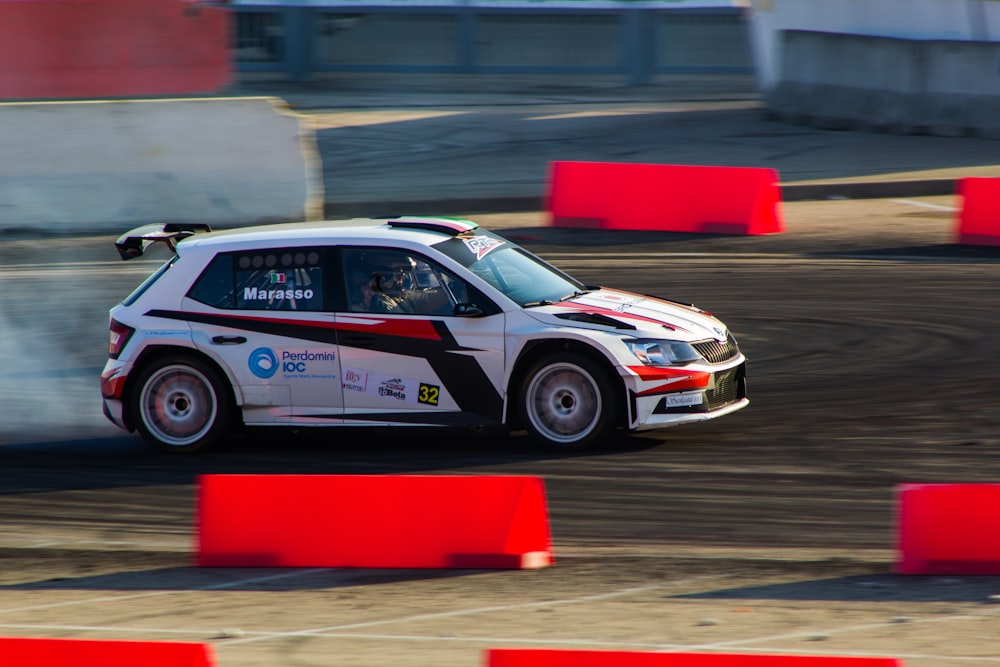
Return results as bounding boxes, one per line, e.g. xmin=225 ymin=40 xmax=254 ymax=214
xmin=129 ymin=355 xmax=233 ymax=454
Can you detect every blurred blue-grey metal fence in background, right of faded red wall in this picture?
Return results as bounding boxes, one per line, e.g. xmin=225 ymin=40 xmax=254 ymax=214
xmin=232 ymin=5 xmax=753 ymax=84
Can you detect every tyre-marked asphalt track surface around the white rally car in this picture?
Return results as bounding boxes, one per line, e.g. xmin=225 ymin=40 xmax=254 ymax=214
xmin=0 ymin=198 xmax=1000 ymax=667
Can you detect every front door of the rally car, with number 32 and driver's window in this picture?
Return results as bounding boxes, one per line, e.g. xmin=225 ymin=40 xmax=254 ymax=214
xmin=337 ymin=247 xmax=504 ymax=424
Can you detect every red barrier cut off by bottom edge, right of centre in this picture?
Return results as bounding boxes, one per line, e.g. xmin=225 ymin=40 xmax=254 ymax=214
xmin=486 ymin=648 xmax=903 ymax=667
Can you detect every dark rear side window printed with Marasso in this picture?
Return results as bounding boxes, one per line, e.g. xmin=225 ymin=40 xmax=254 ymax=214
xmin=188 ymin=248 xmax=325 ymax=311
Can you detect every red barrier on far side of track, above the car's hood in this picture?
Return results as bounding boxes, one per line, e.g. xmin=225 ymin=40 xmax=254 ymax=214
xmin=546 ymin=162 xmax=784 ymax=234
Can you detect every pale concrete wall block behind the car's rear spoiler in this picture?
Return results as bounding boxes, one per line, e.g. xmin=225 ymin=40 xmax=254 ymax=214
xmin=0 ymin=98 xmax=323 ymax=232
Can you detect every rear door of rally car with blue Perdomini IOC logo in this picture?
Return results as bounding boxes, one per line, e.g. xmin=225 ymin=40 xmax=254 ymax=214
xmin=184 ymin=248 xmax=343 ymax=424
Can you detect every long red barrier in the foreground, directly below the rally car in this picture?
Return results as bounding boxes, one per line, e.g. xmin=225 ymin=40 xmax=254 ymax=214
xmin=198 ymin=475 xmax=553 ymax=569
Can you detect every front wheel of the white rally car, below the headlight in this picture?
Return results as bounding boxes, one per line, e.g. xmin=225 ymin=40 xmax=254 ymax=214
xmin=516 ymin=352 xmax=621 ymax=450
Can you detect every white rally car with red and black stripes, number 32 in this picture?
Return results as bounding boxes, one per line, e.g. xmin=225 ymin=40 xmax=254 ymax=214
xmin=101 ymin=217 xmax=748 ymax=452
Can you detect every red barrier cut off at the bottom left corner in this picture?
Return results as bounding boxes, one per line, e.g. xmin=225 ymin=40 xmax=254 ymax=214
xmin=0 ymin=637 xmax=215 ymax=667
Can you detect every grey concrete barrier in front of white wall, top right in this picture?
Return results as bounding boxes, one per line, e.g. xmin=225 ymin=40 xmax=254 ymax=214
xmin=765 ymin=30 xmax=1000 ymax=138
